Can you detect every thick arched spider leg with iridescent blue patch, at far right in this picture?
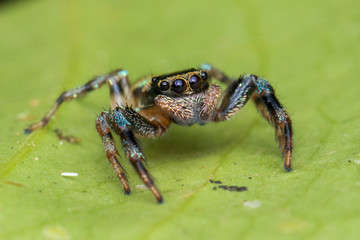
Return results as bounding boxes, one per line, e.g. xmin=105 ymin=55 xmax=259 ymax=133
xmin=214 ymin=75 xmax=293 ymax=172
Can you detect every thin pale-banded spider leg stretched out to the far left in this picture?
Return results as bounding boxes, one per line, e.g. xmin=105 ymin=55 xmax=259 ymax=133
xmin=25 ymin=69 xmax=131 ymax=134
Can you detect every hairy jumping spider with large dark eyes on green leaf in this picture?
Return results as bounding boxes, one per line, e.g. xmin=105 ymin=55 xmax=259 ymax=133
xmin=25 ymin=64 xmax=292 ymax=203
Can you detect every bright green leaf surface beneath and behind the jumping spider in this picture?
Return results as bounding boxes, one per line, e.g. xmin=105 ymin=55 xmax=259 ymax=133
xmin=0 ymin=0 xmax=360 ymax=239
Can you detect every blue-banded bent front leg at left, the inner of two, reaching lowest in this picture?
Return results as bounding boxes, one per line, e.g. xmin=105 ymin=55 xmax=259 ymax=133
xmin=106 ymin=106 xmax=170 ymax=203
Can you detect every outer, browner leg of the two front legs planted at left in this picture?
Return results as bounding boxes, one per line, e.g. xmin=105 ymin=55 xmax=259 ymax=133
xmin=96 ymin=112 xmax=130 ymax=195
